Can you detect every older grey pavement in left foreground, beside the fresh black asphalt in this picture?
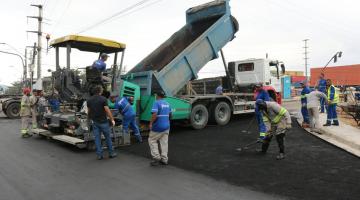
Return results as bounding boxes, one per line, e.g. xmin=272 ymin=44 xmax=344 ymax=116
xmin=0 ymin=118 xmax=279 ymax=200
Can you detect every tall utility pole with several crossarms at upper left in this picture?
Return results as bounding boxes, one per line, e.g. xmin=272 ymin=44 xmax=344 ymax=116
xmin=27 ymin=4 xmax=43 ymax=79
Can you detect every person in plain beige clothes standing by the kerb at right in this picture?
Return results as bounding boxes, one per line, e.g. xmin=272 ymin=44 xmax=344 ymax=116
xmin=306 ymin=91 xmax=327 ymax=133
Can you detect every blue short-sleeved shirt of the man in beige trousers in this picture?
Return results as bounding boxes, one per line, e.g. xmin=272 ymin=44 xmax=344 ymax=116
xmin=151 ymin=99 xmax=171 ymax=132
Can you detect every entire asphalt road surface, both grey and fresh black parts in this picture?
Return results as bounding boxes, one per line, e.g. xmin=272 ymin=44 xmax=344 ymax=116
xmin=0 ymin=102 xmax=360 ymax=199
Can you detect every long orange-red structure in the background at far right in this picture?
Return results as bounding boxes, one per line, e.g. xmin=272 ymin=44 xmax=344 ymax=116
xmin=310 ymin=64 xmax=360 ymax=86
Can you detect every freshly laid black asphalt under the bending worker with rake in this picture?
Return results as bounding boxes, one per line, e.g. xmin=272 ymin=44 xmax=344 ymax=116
xmin=124 ymin=115 xmax=360 ymax=200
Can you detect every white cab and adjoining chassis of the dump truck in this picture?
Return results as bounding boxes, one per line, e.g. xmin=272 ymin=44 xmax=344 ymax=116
xmin=181 ymin=58 xmax=285 ymax=104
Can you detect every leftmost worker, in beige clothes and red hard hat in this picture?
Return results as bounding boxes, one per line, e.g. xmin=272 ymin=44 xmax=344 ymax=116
xmin=20 ymin=88 xmax=31 ymax=138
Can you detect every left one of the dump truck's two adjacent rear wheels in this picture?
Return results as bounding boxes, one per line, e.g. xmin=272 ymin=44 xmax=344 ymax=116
xmin=190 ymin=104 xmax=209 ymax=129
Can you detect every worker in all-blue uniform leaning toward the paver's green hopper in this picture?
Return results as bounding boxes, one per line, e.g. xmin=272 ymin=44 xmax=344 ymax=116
xmin=115 ymin=96 xmax=142 ymax=142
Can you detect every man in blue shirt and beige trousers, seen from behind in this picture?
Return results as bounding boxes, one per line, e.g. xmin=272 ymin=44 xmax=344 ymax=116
xmin=149 ymin=92 xmax=171 ymax=166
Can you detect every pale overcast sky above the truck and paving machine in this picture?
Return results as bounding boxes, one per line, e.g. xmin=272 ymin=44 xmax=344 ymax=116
xmin=0 ymin=0 xmax=360 ymax=84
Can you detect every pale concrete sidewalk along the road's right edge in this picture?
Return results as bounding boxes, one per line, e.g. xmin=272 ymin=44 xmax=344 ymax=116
xmin=297 ymin=112 xmax=360 ymax=157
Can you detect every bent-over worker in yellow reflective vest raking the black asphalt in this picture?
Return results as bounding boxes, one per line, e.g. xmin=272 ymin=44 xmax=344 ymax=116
xmin=256 ymin=99 xmax=291 ymax=160
